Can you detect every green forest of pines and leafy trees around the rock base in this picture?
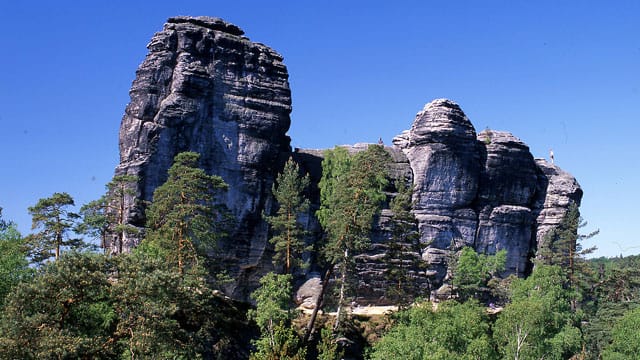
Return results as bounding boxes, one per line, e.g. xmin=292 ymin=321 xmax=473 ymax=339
xmin=0 ymin=145 xmax=640 ymax=360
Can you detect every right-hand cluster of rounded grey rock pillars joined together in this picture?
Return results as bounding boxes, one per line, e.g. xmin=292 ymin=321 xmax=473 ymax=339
xmin=394 ymin=99 xmax=582 ymax=292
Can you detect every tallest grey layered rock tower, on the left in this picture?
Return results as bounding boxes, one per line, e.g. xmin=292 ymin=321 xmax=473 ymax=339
xmin=113 ymin=17 xmax=291 ymax=297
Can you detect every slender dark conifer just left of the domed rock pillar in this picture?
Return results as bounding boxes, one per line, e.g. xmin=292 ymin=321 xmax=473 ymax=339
xmin=384 ymin=180 xmax=426 ymax=305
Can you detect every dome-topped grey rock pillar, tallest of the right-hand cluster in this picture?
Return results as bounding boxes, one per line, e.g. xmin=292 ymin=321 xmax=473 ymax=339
xmin=394 ymin=99 xmax=483 ymax=283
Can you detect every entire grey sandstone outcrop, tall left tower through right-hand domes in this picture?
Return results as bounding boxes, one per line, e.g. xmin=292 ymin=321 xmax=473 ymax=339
xmin=112 ymin=17 xmax=582 ymax=306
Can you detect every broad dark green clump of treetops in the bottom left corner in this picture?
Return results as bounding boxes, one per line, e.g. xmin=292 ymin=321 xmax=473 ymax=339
xmin=0 ymin=251 xmax=238 ymax=359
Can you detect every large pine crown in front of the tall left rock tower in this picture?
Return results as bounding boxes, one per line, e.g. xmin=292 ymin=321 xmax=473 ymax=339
xmin=146 ymin=152 xmax=228 ymax=273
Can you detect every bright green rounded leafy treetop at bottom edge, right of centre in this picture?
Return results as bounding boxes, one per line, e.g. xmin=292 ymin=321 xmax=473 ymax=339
xmin=371 ymin=302 xmax=496 ymax=360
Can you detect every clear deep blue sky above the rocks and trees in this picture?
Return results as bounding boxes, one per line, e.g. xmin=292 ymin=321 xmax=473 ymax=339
xmin=0 ymin=0 xmax=640 ymax=256
